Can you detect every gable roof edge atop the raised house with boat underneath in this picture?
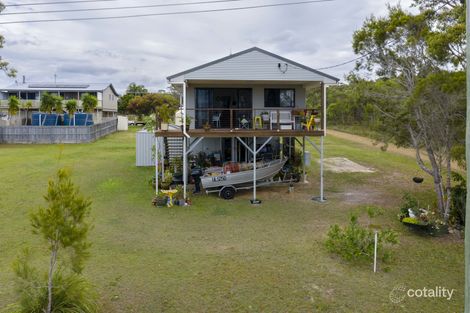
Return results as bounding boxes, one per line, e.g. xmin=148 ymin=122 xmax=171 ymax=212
xmin=167 ymin=47 xmax=339 ymax=82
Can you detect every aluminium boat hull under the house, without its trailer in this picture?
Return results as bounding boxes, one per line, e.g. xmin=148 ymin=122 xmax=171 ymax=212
xmin=201 ymin=158 xmax=287 ymax=192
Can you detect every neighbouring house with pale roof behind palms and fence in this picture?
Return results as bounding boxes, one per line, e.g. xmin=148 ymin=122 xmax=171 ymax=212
xmin=0 ymin=78 xmax=119 ymax=125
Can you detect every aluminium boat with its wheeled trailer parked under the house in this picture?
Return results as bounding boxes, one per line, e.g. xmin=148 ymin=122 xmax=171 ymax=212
xmin=201 ymin=158 xmax=287 ymax=199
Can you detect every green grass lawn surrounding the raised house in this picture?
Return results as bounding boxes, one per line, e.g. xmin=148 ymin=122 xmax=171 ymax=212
xmin=0 ymin=127 xmax=464 ymax=313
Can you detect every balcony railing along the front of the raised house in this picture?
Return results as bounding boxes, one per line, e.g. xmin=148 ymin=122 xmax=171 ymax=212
xmin=187 ymin=108 xmax=323 ymax=130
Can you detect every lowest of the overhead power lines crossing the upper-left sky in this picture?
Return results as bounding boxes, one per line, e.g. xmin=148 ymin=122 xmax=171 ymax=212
xmin=0 ymin=0 xmax=335 ymax=25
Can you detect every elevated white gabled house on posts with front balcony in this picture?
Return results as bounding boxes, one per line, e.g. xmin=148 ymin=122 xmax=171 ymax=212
xmin=156 ymin=47 xmax=338 ymax=201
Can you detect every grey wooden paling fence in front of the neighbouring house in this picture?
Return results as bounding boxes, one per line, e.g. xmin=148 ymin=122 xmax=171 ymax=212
xmin=0 ymin=118 xmax=117 ymax=144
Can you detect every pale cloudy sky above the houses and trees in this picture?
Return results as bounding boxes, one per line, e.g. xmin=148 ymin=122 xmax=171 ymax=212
xmin=0 ymin=0 xmax=411 ymax=93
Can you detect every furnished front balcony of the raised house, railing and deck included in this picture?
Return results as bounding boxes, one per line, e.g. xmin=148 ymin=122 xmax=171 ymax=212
xmin=156 ymin=108 xmax=325 ymax=137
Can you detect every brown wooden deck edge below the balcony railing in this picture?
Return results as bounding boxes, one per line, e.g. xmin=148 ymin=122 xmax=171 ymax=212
xmin=155 ymin=128 xmax=325 ymax=138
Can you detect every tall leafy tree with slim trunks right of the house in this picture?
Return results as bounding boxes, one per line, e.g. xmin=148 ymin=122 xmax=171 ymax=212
xmin=353 ymin=0 xmax=465 ymax=222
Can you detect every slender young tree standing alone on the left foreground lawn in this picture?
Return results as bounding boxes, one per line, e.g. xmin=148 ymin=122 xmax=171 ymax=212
xmin=24 ymin=169 xmax=91 ymax=313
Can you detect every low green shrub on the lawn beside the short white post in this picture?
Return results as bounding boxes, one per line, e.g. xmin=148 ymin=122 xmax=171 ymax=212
xmin=325 ymin=215 xmax=398 ymax=262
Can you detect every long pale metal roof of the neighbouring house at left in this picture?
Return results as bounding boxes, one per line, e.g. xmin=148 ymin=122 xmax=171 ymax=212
xmin=0 ymin=82 xmax=119 ymax=96
